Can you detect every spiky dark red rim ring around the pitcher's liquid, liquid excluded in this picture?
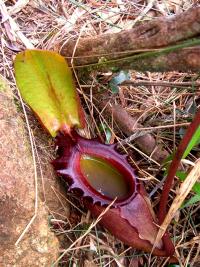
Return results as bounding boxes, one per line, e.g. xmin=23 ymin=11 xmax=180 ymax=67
xmin=53 ymin=132 xmax=137 ymax=205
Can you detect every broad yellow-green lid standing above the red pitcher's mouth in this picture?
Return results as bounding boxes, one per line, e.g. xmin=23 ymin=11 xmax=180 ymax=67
xmin=14 ymin=50 xmax=84 ymax=137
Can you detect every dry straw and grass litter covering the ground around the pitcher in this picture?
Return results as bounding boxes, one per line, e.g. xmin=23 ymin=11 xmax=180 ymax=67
xmin=0 ymin=0 xmax=200 ymax=267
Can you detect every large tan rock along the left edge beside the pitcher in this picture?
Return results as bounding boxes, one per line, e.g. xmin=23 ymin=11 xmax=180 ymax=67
xmin=0 ymin=76 xmax=59 ymax=267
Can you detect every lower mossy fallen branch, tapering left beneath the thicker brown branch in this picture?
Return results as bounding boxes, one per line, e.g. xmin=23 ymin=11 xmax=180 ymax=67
xmin=67 ymin=44 xmax=200 ymax=73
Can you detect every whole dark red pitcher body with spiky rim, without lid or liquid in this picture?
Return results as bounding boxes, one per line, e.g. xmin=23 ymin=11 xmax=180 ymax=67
xmin=53 ymin=131 xmax=174 ymax=256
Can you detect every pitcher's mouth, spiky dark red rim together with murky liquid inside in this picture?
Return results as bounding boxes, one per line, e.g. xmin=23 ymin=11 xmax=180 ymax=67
xmin=53 ymin=133 xmax=138 ymax=207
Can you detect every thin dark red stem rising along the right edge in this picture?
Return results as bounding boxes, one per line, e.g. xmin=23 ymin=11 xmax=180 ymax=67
xmin=158 ymin=109 xmax=200 ymax=225
